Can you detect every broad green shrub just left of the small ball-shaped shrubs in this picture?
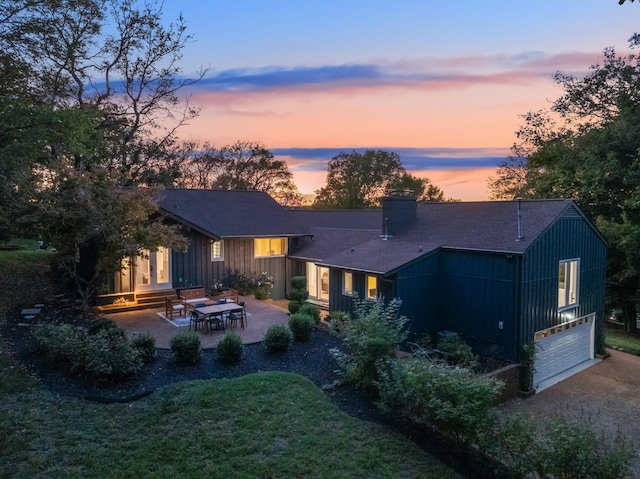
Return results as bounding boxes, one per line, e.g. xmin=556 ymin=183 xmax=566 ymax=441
xmin=81 ymin=328 xmax=143 ymax=379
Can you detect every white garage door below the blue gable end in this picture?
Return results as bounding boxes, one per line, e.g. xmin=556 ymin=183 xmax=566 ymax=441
xmin=533 ymin=314 xmax=595 ymax=390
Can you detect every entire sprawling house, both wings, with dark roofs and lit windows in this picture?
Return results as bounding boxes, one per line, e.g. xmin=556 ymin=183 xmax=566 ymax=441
xmin=95 ymin=190 xmax=607 ymax=388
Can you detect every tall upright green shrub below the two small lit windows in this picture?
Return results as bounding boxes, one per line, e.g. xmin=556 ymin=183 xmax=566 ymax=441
xmin=332 ymin=297 xmax=408 ymax=393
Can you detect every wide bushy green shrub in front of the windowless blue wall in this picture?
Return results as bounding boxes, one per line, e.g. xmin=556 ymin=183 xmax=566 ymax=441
xmin=376 ymin=357 xmax=502 ymax=441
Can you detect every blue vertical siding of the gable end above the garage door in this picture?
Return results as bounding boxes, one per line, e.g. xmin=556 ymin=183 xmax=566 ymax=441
xmin=519 ymin=216 xmax=607 ymax=354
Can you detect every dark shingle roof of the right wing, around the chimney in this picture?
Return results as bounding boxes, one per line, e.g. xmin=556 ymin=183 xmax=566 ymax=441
xmin=295 ymin=200 xmax=573 ymax=274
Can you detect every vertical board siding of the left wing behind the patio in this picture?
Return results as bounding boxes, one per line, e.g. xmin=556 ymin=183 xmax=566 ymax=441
xmin=172 ymin=233 xmax=286 ymax=299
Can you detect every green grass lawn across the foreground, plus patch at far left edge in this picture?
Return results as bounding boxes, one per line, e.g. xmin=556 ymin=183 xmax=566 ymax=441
xmin=0 ymin=251 xmax=459 ymax=478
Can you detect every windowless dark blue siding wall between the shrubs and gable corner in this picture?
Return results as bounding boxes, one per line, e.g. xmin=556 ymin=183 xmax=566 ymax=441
xmin=434 ymin=249 xmax=518 ymax=360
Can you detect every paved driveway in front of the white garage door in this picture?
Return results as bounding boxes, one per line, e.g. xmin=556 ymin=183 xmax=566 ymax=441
xmin=501 ymin=349 xmax=640 ymax=478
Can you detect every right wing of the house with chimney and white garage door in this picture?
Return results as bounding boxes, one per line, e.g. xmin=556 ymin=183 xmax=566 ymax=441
xmin=288 ymin=194 xmax=607 ymax=389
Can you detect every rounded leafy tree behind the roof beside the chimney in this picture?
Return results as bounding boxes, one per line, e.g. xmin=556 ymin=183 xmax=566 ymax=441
xmin=314 ymin=150 xmax=405 ymax=209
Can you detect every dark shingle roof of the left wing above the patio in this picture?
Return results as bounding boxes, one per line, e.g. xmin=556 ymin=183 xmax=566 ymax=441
xmin=158 ymin=189 xmax=309 ymax=238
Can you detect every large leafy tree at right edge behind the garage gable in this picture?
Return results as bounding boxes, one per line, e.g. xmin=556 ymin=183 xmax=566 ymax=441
xmin=492 ymin=35 xmax=640 ymax=330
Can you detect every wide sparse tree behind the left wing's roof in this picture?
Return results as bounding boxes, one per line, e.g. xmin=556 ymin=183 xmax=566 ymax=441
xmin=177 ymin=141 xmax=302 ymax=206
